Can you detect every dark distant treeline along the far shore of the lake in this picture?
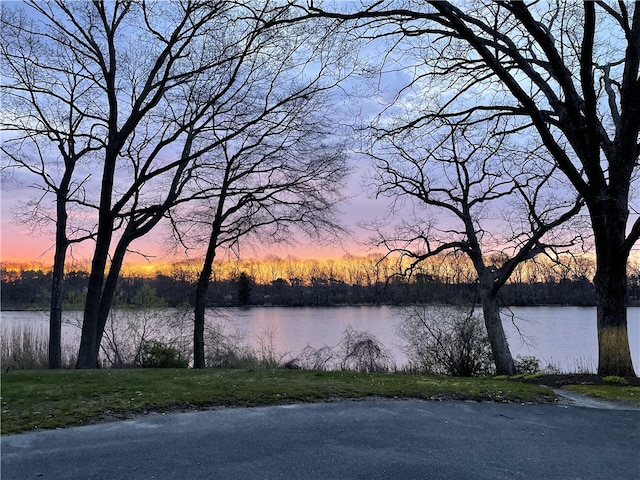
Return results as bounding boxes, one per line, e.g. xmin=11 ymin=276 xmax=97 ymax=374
xmin=5 ymin=264 xmax=640 ymax=310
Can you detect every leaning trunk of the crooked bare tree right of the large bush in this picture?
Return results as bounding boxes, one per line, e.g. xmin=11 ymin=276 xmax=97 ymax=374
xmin=480 ymin=285 xmax=516 ymax=375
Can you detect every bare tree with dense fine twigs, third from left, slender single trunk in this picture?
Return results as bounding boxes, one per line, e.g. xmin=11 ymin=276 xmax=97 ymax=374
xmin=171 ymin=84 xmax=347 ymax=368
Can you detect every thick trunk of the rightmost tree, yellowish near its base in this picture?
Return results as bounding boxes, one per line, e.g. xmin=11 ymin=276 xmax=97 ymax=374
xmin=591 ymin=200 xmax=635 ymax=377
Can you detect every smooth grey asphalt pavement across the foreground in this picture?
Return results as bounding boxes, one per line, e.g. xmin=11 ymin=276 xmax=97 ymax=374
xmin=1 ymin=400 xmax=640 ymax=480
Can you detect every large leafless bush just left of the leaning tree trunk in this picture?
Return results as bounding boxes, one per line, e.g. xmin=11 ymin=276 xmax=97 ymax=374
xmin=399 ymin=306 xmax=493 ymax=377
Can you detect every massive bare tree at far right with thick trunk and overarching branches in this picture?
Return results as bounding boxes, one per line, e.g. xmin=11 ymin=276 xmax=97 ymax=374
xmin=311 ymin=1 xmax=640 ymax=375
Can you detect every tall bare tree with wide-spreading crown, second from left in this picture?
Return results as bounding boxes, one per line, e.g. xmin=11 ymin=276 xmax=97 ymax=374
xmin=3 ymin=0 xmax=342 ymax=368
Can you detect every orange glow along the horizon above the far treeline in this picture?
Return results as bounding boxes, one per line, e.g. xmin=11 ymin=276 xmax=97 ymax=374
xmin=0 ymin=249 xmax=628 ymax=285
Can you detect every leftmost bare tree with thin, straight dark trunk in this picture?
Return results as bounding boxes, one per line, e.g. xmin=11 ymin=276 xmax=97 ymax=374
xmin=0 ymin=6 xmax=101 ymax=368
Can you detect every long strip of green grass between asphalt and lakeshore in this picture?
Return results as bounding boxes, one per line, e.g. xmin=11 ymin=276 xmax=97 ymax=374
xmin=1 ymin=369 xmax=555 ymax=434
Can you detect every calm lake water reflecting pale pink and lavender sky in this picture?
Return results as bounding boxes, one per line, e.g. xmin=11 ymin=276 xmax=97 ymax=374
xmin=2 ymin=306 xmax=640 ymax=374
